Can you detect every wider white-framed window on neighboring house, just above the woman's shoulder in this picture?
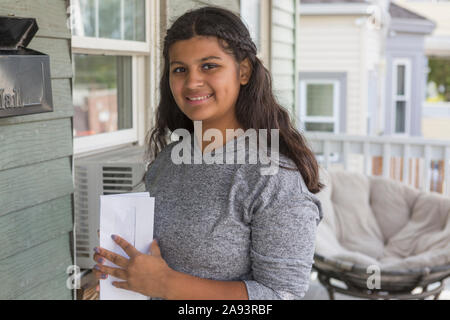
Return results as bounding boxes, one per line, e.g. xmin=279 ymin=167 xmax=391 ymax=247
xmin=300 ymin=79 xmax=341 ymax=133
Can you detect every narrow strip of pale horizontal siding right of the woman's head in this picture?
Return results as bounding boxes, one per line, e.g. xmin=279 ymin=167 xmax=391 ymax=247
xmin=271 ymin=0 xmax=299 ymax=121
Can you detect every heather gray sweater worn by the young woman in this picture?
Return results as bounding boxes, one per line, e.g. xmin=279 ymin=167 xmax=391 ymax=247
xmin=146 ymin=136 xmax=322 ymax=299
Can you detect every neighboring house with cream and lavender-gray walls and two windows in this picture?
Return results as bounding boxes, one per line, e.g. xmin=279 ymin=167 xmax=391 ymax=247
xmin=297 ymin=0 xmax=434 ymax=136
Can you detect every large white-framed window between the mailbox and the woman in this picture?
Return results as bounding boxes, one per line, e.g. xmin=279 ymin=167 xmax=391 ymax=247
xmin=71 ymin=0 xmax=153 ymax=154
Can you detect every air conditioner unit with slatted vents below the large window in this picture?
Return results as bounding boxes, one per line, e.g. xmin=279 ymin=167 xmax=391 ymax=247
xmin=74 ymin=147 xmax=145 ymax=269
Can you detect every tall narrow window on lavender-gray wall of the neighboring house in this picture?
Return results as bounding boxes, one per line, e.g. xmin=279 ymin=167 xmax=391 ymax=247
xmin=392 ymin=59 xmax=411 ymax=134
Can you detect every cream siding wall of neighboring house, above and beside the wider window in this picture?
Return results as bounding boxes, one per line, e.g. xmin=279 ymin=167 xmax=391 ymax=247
xmin=299 ymin=15 xmax=372 ymax=134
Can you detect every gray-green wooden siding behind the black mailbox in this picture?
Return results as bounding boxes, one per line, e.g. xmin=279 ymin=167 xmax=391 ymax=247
xmin=0 ymin=0 xmax=73 ymax=299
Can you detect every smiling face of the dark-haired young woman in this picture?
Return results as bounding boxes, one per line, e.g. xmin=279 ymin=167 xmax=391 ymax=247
xmin=169 ymin=36 xmax=250 ymax=128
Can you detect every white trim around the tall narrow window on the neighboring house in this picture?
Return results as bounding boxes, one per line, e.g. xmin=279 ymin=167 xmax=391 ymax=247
xmin=391 ymin=58 xmax=411 ymax=136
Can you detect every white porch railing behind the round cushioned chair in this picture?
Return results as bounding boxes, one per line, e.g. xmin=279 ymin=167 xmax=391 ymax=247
xmin=305 ymin=132 xmax=450 ymax=196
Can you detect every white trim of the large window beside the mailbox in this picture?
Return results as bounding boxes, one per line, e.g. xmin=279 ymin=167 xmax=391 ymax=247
xmin=72 ymin=0 xmax=154 ymax=156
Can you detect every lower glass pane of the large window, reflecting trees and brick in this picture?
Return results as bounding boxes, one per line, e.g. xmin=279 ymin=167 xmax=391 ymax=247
xmin=73 ymin=53 xmax=133 ymax=137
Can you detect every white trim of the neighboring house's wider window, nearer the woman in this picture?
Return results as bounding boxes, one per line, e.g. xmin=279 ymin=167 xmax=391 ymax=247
xmin=300 ymin=79 xmax=340 ymax=133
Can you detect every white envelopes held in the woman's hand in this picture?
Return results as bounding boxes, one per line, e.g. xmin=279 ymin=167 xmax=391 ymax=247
xmin=100 ymin=192 xmax=155 ymax=300
